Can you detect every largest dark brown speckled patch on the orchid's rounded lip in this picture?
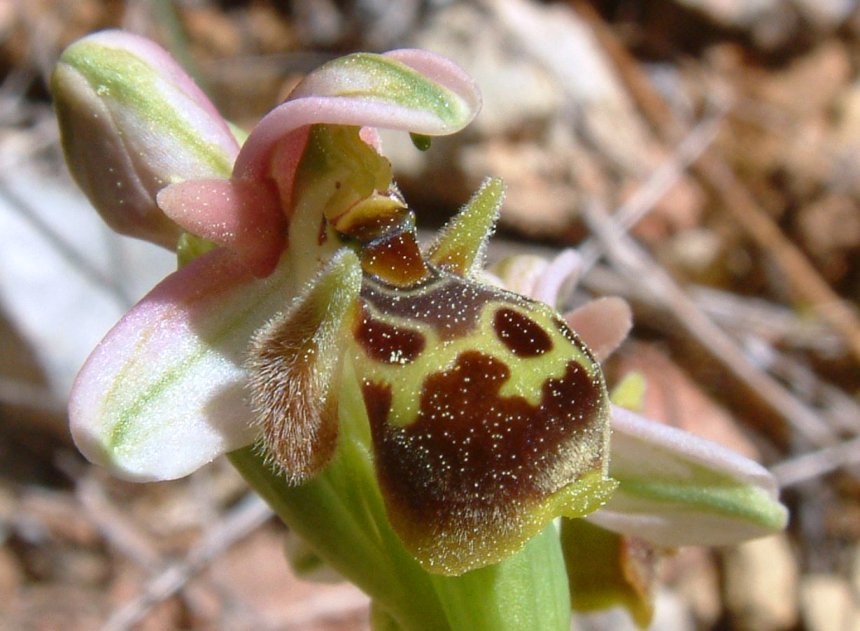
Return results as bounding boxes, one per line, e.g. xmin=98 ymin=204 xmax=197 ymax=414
xmin=363 ymin=351 xmax=603 ymax=537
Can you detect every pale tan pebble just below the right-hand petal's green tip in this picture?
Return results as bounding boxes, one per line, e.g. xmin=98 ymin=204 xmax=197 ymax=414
xmin=723 ymin=533 xmax=798 ymax=631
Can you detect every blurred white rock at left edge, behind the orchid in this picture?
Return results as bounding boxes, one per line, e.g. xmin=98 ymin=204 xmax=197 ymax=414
xmin=0 ymin=166 xmax=176 ymax=401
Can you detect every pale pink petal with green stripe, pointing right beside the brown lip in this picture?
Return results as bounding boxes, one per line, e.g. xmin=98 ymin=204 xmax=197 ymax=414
xmin=587 ymin=406 xmax=788 ymax=547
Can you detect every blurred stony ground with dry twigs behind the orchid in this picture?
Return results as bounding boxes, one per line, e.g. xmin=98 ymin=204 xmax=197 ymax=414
xmin=0 ymin=0 xmax=860 ymax=631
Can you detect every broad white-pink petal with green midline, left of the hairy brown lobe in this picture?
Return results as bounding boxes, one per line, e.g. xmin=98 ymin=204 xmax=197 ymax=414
xmin=69 ymin=249 xmax=298 ymax=481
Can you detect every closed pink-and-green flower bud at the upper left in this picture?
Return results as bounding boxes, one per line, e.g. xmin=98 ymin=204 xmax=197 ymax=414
xmin=51 ymin=31 xmax=239 ymax=248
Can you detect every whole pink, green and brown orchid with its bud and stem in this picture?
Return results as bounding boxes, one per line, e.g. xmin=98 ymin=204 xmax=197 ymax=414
xmin=52 ymin=31 xmax=785 ymax=629
